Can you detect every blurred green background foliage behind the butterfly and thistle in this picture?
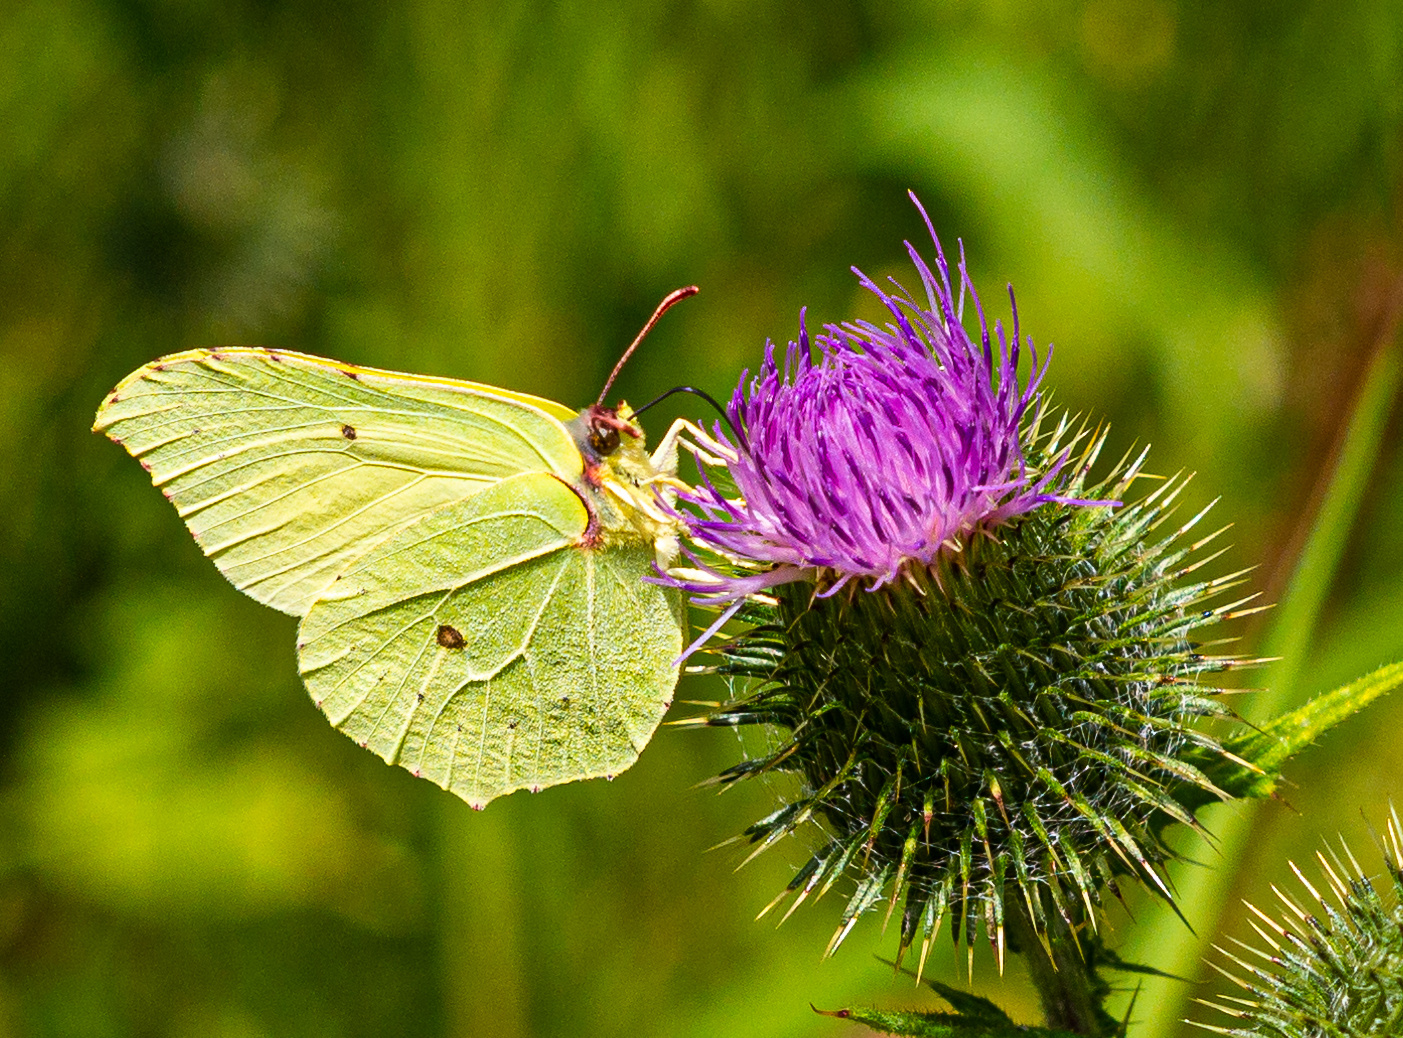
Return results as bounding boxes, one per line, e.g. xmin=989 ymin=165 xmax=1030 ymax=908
xmin=0 ymin=0 xmax=1403 ymax=1038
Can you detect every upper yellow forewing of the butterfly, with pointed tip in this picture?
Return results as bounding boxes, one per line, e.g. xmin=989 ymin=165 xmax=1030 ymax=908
xmin=93 ymin=348 xmax=582 ymax=616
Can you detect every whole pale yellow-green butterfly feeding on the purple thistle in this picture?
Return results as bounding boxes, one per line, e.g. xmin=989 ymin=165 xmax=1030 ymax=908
xmin=93 ymin=289 xmax=696 ymax=808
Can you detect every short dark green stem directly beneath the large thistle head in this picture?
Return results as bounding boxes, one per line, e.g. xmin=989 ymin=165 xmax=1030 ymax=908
xmin=1005 ymin=898 xmax=1115 ymax=1038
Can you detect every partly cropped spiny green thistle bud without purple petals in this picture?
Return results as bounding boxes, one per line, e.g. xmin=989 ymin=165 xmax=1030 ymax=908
xmin=1198 ymin=811 xmax=1403 ymax=1038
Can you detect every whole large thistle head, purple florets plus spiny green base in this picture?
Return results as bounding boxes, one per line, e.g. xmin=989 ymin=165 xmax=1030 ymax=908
xmin=664 ymin=196 xmax=1262 ymax=965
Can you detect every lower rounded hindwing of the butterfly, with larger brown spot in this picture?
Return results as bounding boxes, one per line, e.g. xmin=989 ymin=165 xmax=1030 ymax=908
xmin=297 ymin=473 xmax=682 ymax=807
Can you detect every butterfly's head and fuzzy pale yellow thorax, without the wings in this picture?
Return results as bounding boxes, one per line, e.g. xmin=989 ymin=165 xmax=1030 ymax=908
xmin=567 ymin=404 xmax=679 ymax=565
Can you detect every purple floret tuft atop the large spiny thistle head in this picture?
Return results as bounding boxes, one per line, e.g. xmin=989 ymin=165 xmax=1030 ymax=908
xmin=668 ymin=194 xmax=1115 ymax=613
